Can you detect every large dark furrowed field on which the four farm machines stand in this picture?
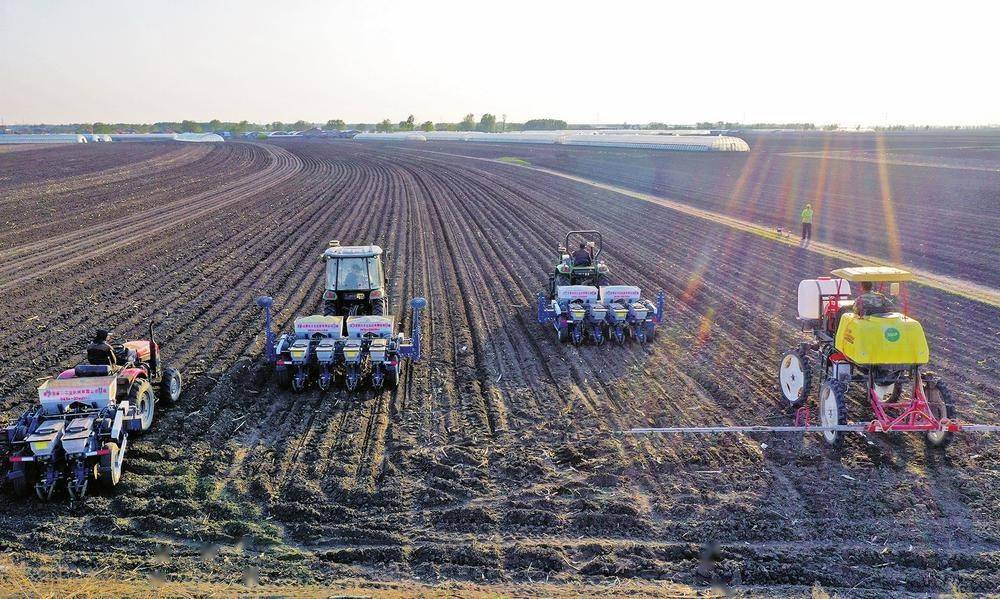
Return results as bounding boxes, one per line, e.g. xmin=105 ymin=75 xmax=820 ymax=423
xmin=0 ymin=141 xmax=1000 ymax=596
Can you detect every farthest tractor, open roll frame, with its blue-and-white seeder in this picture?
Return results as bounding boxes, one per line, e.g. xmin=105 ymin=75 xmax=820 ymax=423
xmin=537 ymin=231 xmax=666 ymax=345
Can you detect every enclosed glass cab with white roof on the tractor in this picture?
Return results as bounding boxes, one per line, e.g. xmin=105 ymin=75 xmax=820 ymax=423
xmin=321 ymin=240 xmax=388 ymax=316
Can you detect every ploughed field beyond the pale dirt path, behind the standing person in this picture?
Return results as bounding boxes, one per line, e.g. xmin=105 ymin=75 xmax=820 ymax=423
xmin=414 ymin=132 xmax=1000 ymax=286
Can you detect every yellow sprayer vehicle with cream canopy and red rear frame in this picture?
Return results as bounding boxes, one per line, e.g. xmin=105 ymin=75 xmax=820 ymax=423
xmin=778 ymin=267 xmax=962 ymax=447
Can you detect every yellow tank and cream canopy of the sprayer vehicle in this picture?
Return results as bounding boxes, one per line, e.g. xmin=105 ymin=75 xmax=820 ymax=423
xmin=831 ymin=266 xmax=930 ymax=365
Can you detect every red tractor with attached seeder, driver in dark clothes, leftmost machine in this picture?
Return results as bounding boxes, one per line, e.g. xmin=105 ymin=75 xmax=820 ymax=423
xmin=0 ymin=322 xmax=182 ymax=500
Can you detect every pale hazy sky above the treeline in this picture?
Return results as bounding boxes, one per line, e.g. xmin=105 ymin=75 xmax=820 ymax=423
xmin=0 ymin=0 xmax=1000 ymax=126
